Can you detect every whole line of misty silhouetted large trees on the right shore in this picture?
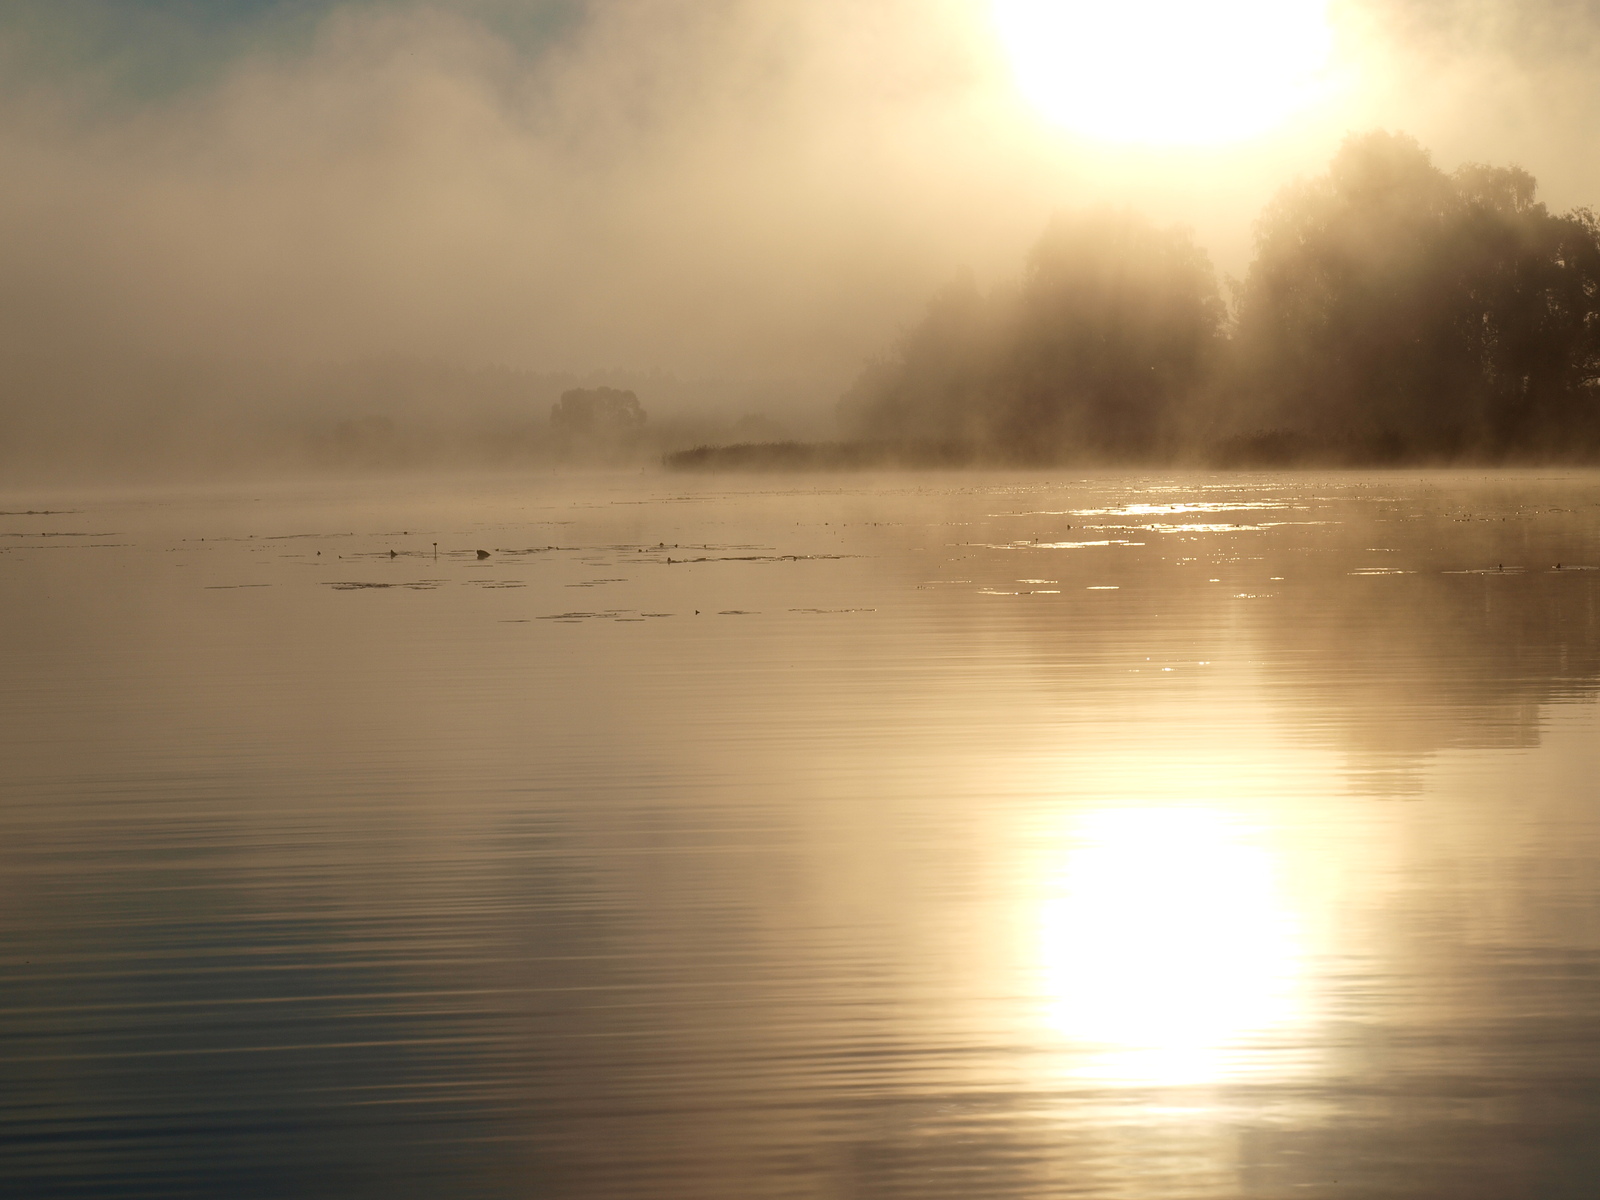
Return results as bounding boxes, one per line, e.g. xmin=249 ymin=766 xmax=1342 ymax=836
xmin=840 ymin=133 xmax=1600 ymax=462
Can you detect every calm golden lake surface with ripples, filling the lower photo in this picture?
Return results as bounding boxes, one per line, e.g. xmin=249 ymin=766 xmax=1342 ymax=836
xmin=0 ymin=474 xmax=1600 ymax=1200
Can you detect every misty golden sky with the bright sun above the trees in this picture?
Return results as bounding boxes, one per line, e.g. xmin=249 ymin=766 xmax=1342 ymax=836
xmin=0 ymin=0 xmax=1600 ymax=403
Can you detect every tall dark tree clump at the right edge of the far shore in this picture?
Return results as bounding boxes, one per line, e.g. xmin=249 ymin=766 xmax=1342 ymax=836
xmin=1234 ymin=133 xmax=1600 ymax=458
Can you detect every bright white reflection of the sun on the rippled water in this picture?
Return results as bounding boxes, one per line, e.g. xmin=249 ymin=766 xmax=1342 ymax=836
xmin=1038 ymin=808 xmax=1302 ymax=1083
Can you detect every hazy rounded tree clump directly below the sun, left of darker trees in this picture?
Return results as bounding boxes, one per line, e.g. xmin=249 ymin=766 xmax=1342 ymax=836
xmin=840 ymin=208 xmax=1226 ymax=461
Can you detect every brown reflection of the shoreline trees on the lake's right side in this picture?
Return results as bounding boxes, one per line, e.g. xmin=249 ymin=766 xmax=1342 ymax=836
xmin=902 ymin=475 xmax=1600 ymax=765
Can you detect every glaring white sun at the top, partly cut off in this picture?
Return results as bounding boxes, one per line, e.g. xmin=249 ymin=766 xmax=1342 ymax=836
xmin=992 ymin=0 xmax=1333 ymax=146
